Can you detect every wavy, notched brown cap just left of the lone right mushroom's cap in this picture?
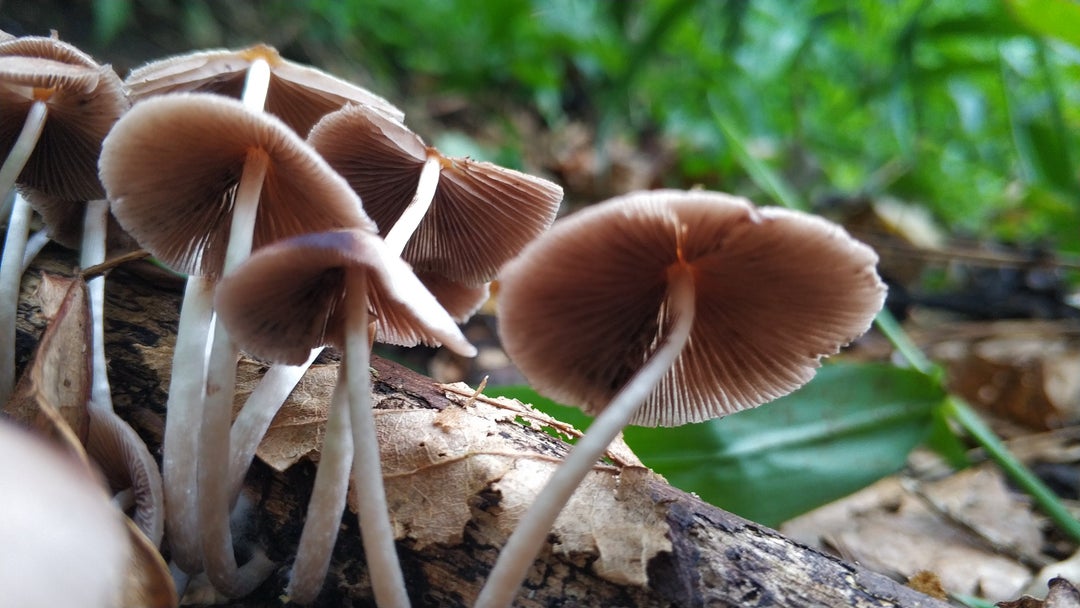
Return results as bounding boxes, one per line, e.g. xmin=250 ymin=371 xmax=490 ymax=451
xmin=308 ymin=106 xmax=563 ymax=285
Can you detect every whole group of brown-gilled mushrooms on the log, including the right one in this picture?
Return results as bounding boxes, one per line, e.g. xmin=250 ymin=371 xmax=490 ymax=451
xmin=0 ymin=32 xmax=885 ymax=607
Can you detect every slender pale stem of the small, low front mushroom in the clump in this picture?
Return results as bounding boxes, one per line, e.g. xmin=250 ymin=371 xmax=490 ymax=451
xmin=341 ymin=271 xmax=409 ymax=608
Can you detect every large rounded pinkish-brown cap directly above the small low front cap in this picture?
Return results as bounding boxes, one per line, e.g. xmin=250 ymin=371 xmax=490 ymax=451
xmin=100 ymin=93 xmax=375 ymax=279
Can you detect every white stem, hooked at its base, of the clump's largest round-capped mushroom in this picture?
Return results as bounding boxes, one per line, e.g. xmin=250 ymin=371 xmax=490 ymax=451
xmin=198 ymin=149 xmax=273 ymax=597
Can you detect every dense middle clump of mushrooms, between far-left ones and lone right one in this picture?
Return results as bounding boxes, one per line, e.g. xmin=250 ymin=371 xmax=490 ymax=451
xmin=90 ymin=40 xmax=562 ymax=606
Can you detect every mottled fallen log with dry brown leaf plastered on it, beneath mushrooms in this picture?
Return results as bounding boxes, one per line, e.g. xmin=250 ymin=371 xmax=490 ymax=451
xmin=17 ymin=247 xmax=947 ymax=607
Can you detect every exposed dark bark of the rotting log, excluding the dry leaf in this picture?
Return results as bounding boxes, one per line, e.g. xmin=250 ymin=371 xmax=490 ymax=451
xmin=17 ymin=247 xmax=946 ymax=608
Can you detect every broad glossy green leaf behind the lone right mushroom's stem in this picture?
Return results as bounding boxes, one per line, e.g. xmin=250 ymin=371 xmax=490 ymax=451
xmin=487 ymin=364 xmax=944 ymax=525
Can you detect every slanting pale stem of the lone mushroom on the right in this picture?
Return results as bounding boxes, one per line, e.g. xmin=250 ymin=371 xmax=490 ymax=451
xmin=474 ymin=269 xmax=694 ymax=608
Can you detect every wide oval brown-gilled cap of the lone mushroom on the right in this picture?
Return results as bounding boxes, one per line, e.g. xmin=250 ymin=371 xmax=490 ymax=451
xmin=498 ymin=190 xmax=886 ymax=427
